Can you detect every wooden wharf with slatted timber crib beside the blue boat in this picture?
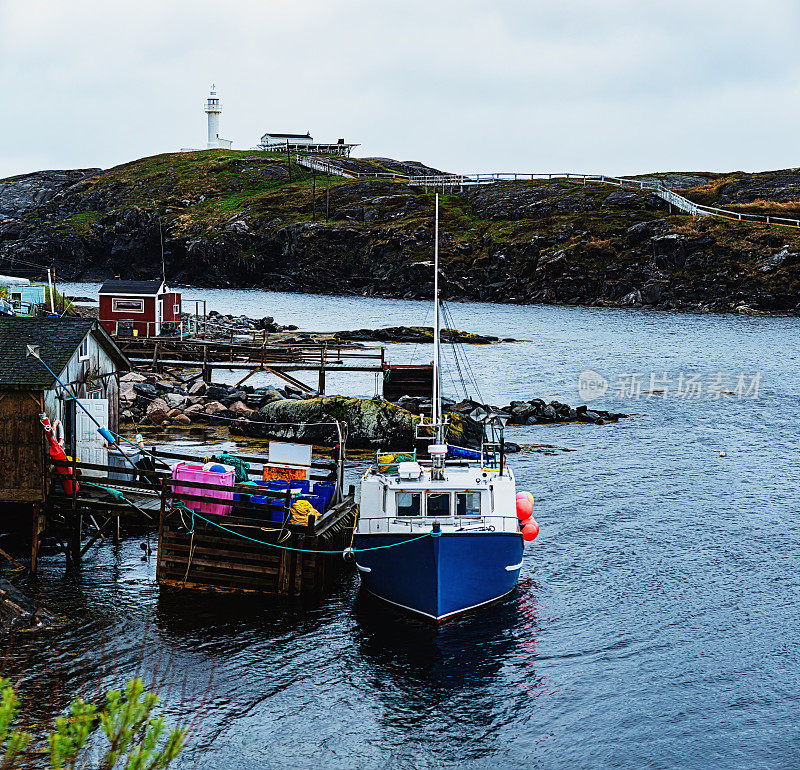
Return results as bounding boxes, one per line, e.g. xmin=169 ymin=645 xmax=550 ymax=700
xmin=39 ymin=440 xmax=356 ymax=597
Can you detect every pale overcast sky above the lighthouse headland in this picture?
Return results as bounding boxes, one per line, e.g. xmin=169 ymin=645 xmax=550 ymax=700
xmin=0 ymin=0 xmax=800 ymax=177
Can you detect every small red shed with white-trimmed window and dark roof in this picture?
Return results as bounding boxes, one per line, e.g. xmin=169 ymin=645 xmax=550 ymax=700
xmin=100 ymin=280 xmax=181 ymax=337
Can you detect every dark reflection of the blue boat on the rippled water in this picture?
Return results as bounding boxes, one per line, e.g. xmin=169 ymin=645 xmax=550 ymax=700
xmin=354 ymin=582 xmax=544 ymax=766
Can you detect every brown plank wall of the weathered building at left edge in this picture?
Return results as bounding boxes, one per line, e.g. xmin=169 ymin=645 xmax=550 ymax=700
xmin=0 ymin=391 xmax=44 ymax=502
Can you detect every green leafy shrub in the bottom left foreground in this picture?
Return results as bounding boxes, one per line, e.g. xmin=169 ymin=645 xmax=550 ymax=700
xmin=0 ymin=678 xmax=187 ymax=770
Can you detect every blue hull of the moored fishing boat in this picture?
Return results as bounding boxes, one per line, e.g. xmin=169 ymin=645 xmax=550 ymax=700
xmin=354 ymin=532 xmax=523 ymax=622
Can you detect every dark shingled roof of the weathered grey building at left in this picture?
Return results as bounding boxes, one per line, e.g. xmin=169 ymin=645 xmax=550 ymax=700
xmin=0 ymin=316 xmax=131 ymax=389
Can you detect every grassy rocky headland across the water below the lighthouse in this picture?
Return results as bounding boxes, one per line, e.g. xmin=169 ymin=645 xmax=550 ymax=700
xmin=0 ymin=151 xmax=800 ymax=314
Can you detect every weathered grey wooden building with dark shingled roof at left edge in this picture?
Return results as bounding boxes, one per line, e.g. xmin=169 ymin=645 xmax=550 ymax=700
xmin=0 ymin=317 xmax=131 ymax=506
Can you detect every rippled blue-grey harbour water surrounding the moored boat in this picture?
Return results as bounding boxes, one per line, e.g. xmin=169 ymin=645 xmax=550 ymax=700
xmin=15 ymin=285 xmax=800 ymax=770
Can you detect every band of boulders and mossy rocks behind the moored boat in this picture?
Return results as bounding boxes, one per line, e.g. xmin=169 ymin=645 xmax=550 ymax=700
xmin=120 ymin=372 xmax=627 ymax=451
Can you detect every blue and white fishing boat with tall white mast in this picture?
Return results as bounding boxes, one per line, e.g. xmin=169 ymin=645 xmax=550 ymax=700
xmin=354 ymin=196 xmax=538 ymax=622
